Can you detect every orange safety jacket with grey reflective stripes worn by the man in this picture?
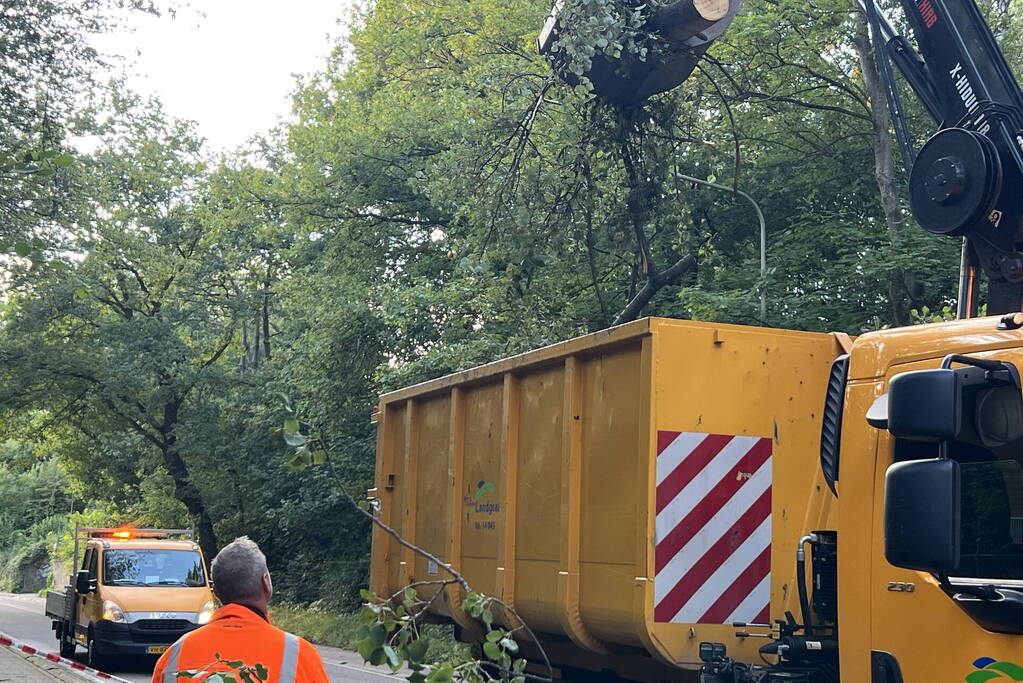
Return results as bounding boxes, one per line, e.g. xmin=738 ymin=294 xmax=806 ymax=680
xmin=152 ymin=603 xmax=329 ymax=683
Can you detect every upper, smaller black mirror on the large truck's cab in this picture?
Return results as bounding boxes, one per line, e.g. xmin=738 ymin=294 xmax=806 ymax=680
xmin=887 ymin=368 xmax=963 ymax=441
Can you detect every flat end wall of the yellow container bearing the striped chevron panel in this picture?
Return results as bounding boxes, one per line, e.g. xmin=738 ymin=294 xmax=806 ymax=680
xmin=646 ymin=321 xmax=841 ymax=665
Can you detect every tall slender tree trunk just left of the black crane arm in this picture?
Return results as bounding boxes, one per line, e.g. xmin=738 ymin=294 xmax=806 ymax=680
xmin=852 ymin=7 xmax=918 ymax=325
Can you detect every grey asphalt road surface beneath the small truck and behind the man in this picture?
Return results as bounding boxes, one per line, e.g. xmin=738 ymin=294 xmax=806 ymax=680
xmin=0 ymin=593 xmax=404 ymax=683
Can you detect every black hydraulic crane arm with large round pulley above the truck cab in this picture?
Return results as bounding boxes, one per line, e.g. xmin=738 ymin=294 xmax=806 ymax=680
xmin=865 ymin=0 xmax=1023 ymax=317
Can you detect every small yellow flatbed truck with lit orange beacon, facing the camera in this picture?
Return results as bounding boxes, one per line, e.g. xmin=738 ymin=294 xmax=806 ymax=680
xmin=46 ymin=528 xmax=215 ymax=669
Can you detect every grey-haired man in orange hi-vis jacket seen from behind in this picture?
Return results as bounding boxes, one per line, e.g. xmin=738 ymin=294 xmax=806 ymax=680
xmin=152 ymin=536 xmax=328 ymax=683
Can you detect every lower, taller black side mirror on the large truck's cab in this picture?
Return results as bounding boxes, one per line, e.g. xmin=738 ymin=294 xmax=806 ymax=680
xmin=885 ymin=459 xmax=961 ymax=574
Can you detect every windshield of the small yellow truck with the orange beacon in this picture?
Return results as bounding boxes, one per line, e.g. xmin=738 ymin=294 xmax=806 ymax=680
xmin=103 ymin=549 xmax=206 ymax=587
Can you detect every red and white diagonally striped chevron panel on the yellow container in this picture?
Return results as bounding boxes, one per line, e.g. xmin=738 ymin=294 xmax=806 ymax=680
xmin=654 ymin=431 xmax=772 ymax=624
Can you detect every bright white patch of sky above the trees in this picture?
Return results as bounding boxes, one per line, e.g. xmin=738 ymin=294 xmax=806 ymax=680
xmin=97 ymin=0 xmax=350 ymax=149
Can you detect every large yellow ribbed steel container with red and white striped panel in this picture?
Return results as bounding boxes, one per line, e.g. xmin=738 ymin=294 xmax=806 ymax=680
xmin=371 ymin=318 xmax=847 ymax=680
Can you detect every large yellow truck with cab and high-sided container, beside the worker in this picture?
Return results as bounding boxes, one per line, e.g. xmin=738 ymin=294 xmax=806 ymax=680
xmin=370 ymin=315 xmax=1023 ymax=683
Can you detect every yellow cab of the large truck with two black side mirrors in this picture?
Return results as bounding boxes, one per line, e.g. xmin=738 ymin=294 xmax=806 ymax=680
xmin=828 ymin=318 xmax=1023 ymax=681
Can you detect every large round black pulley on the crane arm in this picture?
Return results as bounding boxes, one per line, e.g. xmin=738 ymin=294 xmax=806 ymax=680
xmin=909 ymin=128 xmax=1002 ymax=235
